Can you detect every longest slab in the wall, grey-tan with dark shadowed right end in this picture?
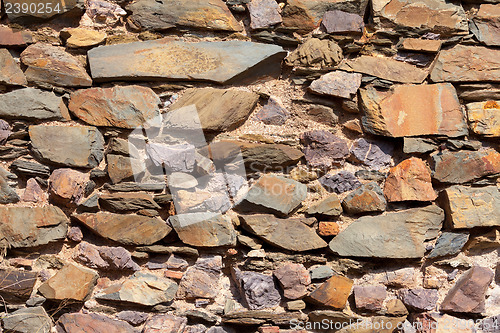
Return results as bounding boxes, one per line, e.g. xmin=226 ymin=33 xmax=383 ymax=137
xmin=88 ymin=39 xmax=286 ymax=83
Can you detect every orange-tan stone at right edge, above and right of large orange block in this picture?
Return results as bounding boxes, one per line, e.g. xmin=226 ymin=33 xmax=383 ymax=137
xmin=431 ymin=45 xmax=500 ymax=82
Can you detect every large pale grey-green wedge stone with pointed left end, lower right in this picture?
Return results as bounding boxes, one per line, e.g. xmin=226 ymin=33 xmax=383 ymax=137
xmin=330 ymin=205 xmax=444 ymax=258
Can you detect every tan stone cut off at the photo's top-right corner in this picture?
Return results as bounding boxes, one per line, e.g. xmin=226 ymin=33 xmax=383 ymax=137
xmin=470 ymin=4 xmax=500 ymax=46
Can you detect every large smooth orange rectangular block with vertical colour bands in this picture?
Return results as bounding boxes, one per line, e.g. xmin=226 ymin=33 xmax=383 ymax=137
xmin=361 ymin=84 xmax=468 ymax=137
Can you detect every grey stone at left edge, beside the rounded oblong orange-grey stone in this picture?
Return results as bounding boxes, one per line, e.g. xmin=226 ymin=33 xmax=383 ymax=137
xmin=0 ymin=88 xmax=70 ymax=121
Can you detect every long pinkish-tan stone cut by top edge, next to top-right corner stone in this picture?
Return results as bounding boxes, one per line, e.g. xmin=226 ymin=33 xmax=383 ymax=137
xmin=373 ymin=0 xmax=469 ymax=35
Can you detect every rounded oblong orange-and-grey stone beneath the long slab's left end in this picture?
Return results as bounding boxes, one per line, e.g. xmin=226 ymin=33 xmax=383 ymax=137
xmin=68 ymin=86 xmax=160 ymax=129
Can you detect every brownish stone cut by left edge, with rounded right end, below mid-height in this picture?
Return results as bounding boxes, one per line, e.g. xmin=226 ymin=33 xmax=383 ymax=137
xmin=0 ymin=206 xmax=69 ymax=248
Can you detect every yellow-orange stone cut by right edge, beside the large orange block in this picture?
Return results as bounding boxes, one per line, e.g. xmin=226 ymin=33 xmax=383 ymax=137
xmin=467 ymin=101 xmax=500 ymax=137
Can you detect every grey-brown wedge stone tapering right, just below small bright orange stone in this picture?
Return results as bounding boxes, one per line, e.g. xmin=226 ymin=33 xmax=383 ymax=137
xmin=240 ymin=214 xmax=327 ymax=251
